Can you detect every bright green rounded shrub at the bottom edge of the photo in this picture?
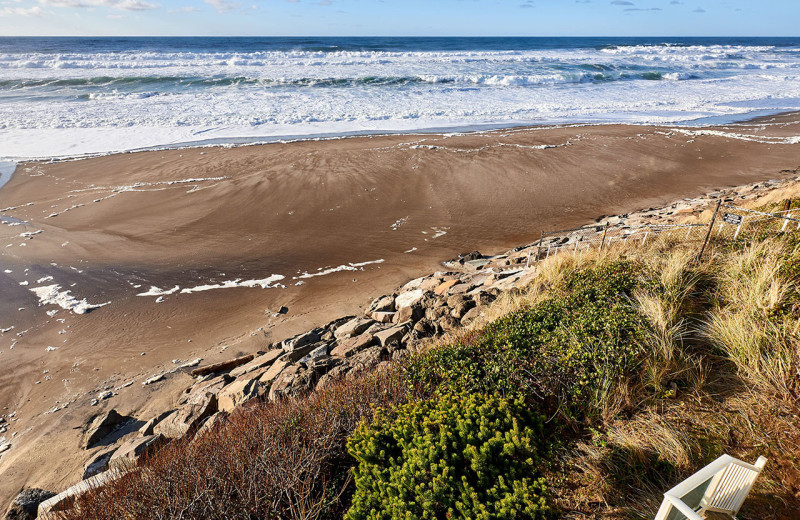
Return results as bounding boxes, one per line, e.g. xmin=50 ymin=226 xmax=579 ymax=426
xmin=345 ymin=394 xmax=553 ymax=520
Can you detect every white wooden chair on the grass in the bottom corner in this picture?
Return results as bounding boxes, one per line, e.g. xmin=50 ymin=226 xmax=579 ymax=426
xmin=655 ymin=455 xmax=767 ymax=520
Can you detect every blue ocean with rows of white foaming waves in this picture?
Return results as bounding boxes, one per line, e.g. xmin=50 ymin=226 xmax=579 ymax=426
xmin=0 ymin=38 xmax=800 ymax=160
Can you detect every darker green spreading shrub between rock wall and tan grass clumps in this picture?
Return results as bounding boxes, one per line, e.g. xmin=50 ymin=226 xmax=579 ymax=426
xmin=407 ymin=261 xmax=646 ymax=414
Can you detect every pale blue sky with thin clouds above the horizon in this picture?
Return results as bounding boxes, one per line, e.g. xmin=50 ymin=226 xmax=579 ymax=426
xmin=0 ymin=0 xmax=800 ymax=36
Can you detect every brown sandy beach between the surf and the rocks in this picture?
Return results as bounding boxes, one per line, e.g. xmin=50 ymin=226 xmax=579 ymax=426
xmin=0 ymin=114 xmax=800 ymax=507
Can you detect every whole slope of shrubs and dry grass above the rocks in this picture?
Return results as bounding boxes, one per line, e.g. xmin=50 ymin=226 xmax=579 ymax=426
xmin=59 ymin=220 xmax=800 ymax=520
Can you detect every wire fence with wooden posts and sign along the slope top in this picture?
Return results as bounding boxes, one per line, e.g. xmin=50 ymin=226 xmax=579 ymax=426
xmin=527 ymin=201 xmax=800 ymax=265
